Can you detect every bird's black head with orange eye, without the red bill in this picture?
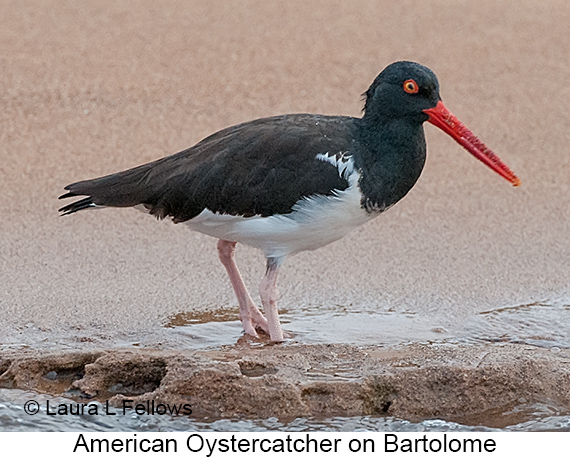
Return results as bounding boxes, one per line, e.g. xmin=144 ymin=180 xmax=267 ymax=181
xmin=364 ymin=62 xmax=440 ymax=123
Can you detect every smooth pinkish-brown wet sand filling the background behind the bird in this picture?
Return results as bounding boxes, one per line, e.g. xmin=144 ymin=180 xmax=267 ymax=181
xmin=0 ymin=1 xmax=570 ymax=428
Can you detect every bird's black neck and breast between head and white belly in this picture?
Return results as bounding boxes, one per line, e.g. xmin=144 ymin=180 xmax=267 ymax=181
xmin=355 ymin=117 xmax=426 ymax=212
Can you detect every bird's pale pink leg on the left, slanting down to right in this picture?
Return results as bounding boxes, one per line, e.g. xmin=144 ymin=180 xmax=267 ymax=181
xmin=218 ymin=240 xmax=270 ymax=338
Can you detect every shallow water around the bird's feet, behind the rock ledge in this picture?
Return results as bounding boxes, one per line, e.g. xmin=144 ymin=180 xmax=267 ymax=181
xmin=167 ymin=303 xmax=570 ymax=351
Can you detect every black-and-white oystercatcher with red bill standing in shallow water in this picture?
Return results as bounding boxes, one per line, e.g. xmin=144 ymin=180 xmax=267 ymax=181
xmin=59 ymin=61 xmax=520 ymax=342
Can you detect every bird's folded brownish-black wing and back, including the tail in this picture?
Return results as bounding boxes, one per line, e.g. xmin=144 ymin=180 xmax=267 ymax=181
xmin=60 ymin=114 xmax=354 ymax=222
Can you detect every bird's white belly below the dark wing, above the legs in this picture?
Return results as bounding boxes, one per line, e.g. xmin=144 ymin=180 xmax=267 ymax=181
xmin=185 ymin=172 xmax=378 ymax=258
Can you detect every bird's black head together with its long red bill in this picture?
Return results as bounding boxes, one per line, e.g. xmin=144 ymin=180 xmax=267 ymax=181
xmin=364 ymin=61 xmax=520 ymax=186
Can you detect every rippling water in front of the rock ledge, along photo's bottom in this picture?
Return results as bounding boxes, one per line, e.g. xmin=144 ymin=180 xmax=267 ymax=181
xmin=0 ymin=389 xmax=570 ymax=432
